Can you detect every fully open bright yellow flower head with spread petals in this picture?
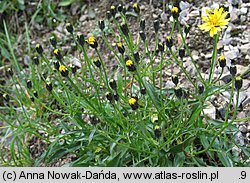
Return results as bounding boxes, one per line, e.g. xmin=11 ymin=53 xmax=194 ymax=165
xmin=199 ymin=8 xmax=230 ymax=37
